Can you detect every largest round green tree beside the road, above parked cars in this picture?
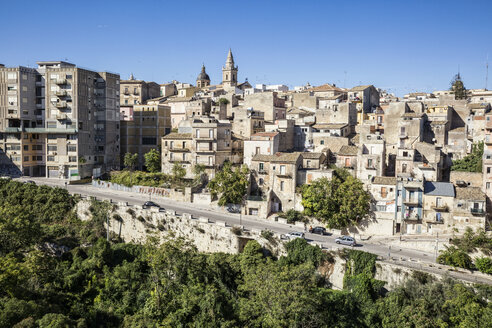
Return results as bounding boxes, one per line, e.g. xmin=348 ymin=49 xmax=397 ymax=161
xmin=302 ymin=169 xmax=370 ymax=229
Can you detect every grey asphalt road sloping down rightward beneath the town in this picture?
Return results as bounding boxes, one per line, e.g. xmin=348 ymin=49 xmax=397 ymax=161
xmin=17 ymin=177 xmax=492 ymax=284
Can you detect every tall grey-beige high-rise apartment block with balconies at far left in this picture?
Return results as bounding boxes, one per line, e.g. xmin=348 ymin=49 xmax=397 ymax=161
xmin=0 ymin=61 xmax=120 ymax=179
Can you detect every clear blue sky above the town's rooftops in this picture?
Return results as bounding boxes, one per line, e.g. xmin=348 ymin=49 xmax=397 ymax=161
xmin=0 ymin=0 xmax=492 ymax=95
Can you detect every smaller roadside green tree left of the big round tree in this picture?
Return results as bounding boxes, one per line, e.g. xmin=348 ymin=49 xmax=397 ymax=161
xmin=208 ymin=162 xmax=249 ymax=206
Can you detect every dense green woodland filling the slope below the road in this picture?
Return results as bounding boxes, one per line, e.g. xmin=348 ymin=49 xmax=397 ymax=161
xmin=0 ymin=181 xmax=492 ymax=328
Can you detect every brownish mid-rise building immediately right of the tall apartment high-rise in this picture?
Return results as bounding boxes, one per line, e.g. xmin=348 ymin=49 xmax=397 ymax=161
xmin=120 ymin=102 xmax=171 ymax=169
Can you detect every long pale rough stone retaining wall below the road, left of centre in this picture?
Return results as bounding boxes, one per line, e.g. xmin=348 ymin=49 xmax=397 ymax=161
xmin=77 ymin=200 xmax=284 ymax=255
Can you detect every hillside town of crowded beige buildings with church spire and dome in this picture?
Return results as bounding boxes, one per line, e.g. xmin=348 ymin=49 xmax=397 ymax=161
xmin=0 ymin=50 xmax=492 ymax=241
